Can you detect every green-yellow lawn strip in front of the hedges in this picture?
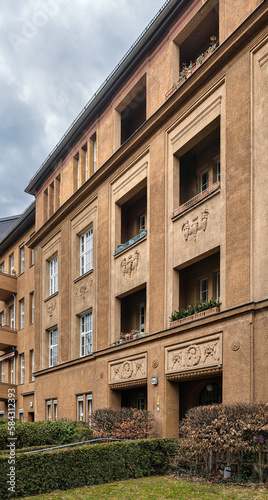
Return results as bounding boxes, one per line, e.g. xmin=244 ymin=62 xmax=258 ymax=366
xmin=19 ymin=476 xmax=268 ymax=500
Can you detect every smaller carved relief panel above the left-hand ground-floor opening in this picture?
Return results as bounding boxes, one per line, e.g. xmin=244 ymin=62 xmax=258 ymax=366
xmin=109 ymin=354 xmax=147 ymax=384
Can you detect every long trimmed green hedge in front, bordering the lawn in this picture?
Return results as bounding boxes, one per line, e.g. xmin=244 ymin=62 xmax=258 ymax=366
xmin=0 ymin=439 xmax=176 ymax=499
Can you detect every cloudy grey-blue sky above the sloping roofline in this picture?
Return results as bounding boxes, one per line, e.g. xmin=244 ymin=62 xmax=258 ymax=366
xmin=0 ymin=0 xmax=164 ymax=218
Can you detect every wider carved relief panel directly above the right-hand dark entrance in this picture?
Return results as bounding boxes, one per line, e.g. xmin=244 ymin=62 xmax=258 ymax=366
xmin=165 ymin=334 xmax=222 ymax=374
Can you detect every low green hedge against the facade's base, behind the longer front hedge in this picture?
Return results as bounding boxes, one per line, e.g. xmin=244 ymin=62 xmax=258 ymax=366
xmin=0 ymin=422 xmax=93 ymax=450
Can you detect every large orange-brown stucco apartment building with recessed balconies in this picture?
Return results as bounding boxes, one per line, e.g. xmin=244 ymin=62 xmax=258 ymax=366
xmin=0 ymin=0 xmax=268 ymax=436
